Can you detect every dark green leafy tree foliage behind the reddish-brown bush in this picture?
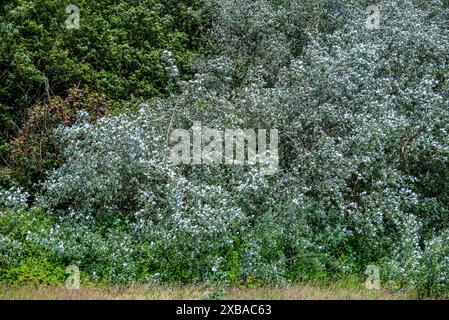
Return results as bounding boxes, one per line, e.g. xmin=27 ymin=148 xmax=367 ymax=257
xmin=0 ymin=0 xmax=201 ymax=170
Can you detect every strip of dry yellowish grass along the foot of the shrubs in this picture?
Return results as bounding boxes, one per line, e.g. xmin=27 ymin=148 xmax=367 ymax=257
xmin=0 ymin=283 xmax=416 ymax=300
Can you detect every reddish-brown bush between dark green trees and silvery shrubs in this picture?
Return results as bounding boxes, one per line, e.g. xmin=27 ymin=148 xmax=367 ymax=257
xmin=8 ymin=88 xmax=108 ymax=191
